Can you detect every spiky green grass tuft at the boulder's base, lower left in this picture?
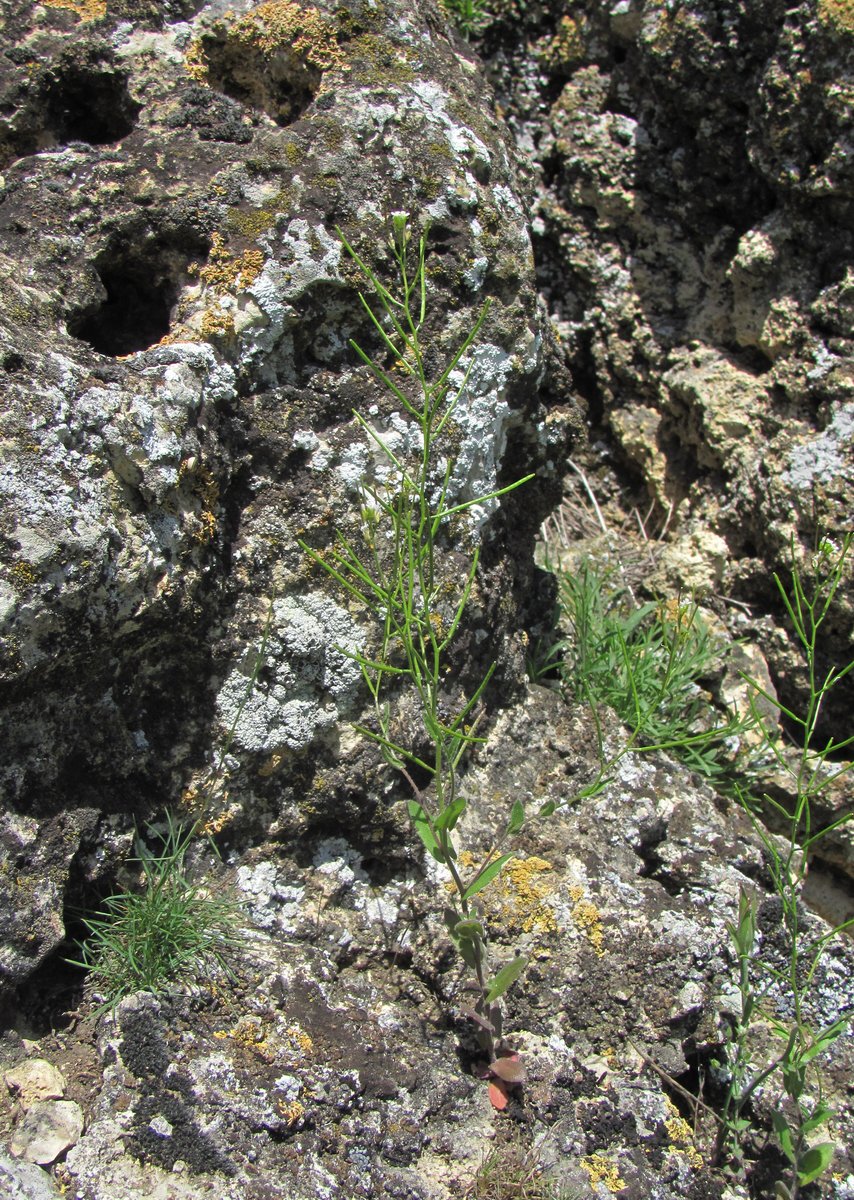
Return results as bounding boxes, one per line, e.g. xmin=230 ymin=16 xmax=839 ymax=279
xmin=68 ymin=815 xmax=242 ymax=1009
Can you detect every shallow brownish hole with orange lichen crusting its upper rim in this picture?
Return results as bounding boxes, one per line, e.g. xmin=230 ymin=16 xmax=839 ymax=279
xmin=195 ymin=36 xmax=321 ymax=125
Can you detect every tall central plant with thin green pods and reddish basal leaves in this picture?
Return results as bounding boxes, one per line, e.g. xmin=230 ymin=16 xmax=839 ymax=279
xmin=300 ymin=212 xmax=533 ymax=1108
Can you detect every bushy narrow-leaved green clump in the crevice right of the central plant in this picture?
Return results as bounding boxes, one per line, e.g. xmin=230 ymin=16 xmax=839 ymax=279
xmin=546 ymin=562 xmax=754 ymax=787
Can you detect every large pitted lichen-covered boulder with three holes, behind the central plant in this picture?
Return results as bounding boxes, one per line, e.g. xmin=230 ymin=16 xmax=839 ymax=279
xmin=0 ymin=0 xmax=569 ymax=983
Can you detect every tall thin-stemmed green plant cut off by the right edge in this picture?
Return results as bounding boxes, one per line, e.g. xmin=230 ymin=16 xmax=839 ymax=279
xmin=717 ymin=534 xmax=854 ymax=1200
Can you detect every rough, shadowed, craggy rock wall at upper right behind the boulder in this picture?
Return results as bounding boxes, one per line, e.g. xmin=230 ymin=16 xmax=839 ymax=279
xmin=483 ymin=0 xmax=854 ymax=720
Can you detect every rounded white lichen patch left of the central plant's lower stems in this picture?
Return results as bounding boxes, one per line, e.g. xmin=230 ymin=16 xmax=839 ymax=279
xmin=217 ymin=592 xmax=361 ymax=755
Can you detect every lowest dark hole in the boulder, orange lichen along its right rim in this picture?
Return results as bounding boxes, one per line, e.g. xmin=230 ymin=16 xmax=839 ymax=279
xmin=68 ymin=228 xmax=210 ymax=356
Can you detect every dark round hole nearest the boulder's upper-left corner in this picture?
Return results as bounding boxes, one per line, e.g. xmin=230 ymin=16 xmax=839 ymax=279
xmin=43 ymin=58 xmax=142 ymax=146
